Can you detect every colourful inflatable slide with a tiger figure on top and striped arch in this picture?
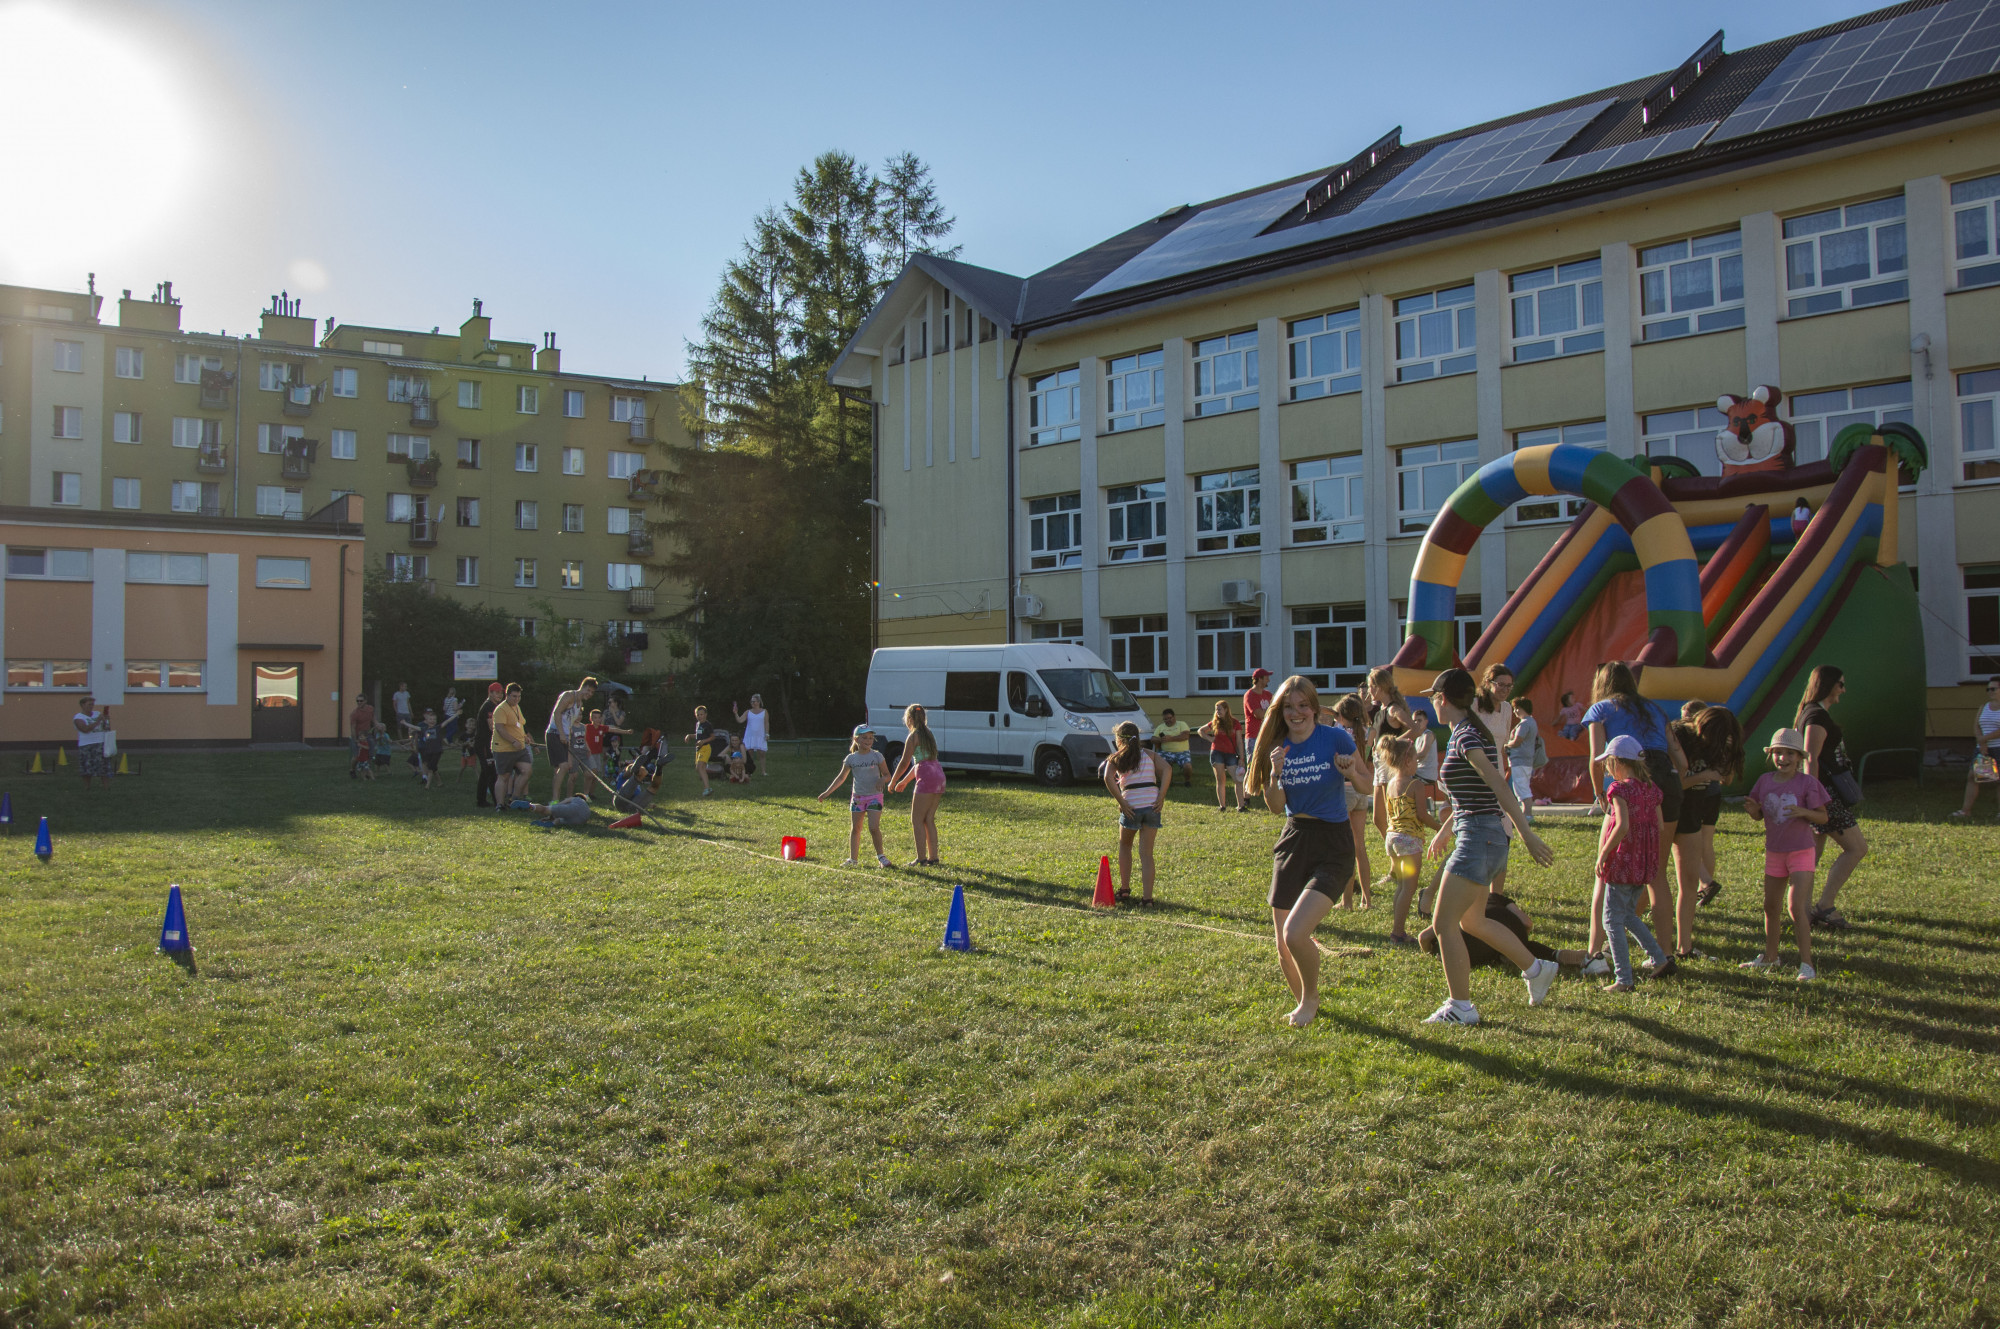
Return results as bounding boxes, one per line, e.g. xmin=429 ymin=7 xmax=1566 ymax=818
xmin=1394 ymin=388 xmax=1928 ymax=803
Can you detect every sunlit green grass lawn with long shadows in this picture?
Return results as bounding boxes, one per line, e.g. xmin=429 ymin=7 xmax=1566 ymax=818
xmin=0 ymin=753 xmax=2000 ymax=1327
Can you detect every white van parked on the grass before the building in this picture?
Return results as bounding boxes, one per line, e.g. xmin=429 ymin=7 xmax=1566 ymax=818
xmin=868 ymin=642 xmax=1152 ymax=785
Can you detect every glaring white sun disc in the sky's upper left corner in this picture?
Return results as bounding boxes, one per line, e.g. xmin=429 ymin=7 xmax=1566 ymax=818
xmin=0 ymin=0 xmax=202 ymax=286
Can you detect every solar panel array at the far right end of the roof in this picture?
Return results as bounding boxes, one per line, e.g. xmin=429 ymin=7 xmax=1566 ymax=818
xmin=1716 ymin=0 xmax=2000 ymax=142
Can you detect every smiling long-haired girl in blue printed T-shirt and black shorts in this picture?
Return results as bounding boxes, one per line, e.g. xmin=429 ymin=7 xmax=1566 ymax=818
xmin=1244 ymin=675 xmax=1356 ymax=1029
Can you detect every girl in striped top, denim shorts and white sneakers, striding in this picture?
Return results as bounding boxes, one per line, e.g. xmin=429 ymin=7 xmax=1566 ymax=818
xmin=1424 ymin=669 xmax=1558 ymax=1025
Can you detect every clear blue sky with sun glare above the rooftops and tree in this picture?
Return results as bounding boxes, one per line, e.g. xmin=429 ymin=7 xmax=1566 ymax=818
xmin=0 ymin=0 xmax=1862 ymax=378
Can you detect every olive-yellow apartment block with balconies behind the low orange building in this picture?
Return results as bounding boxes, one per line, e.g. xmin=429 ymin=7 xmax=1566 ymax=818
xmin=0 ymin=280 xmax=686 ymax=669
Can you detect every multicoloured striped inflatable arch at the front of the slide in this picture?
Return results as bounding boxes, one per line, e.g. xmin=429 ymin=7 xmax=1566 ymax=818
xmin=1394 ymin=442 xmax=1708 ymax=691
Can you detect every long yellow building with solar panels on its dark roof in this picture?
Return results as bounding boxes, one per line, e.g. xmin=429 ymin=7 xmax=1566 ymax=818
xmin=832 ymin=0 xmax=2000 ymax=737
